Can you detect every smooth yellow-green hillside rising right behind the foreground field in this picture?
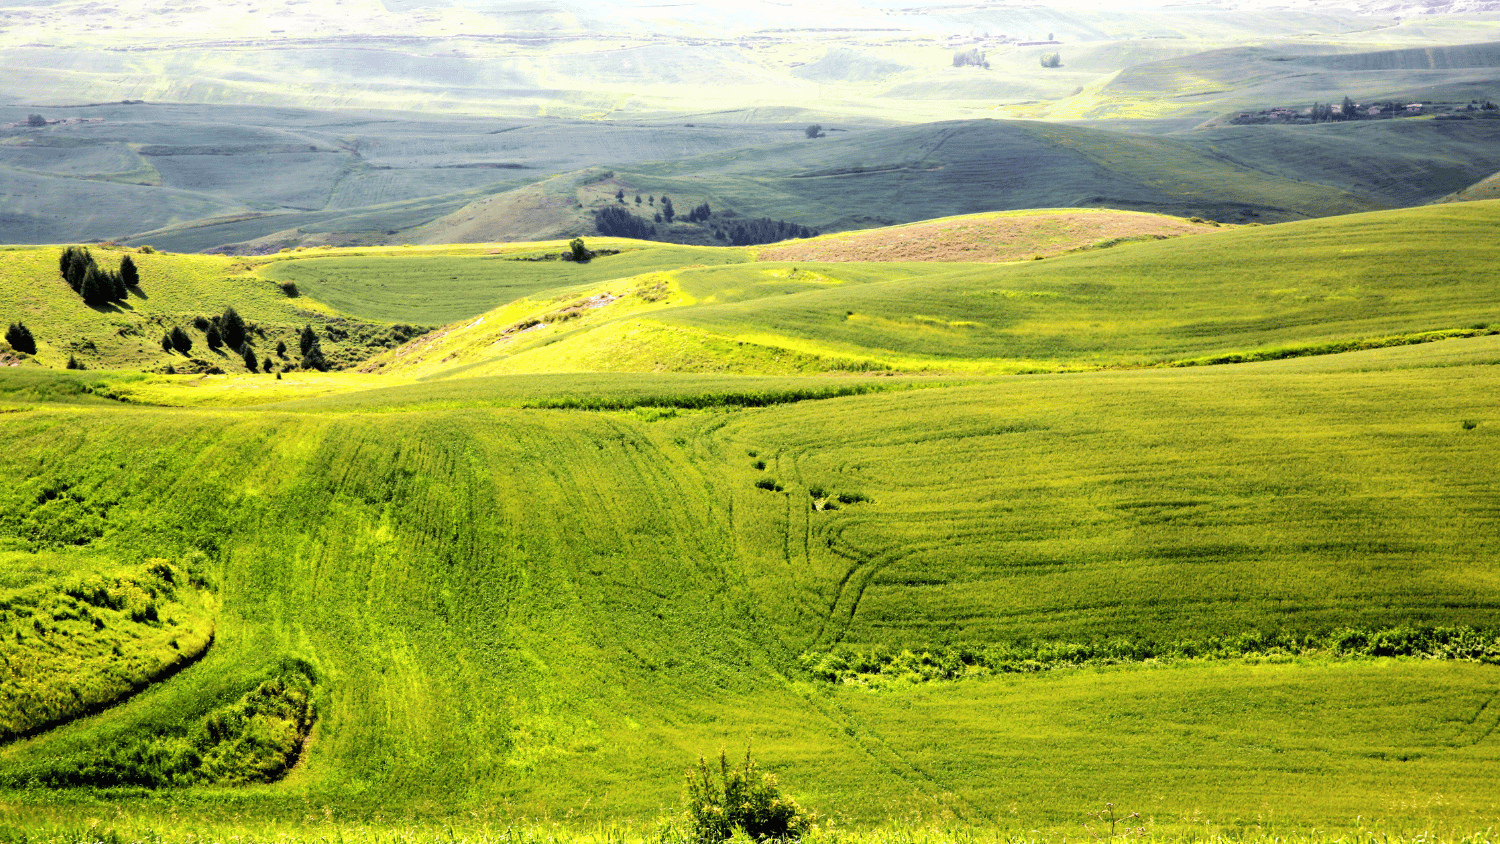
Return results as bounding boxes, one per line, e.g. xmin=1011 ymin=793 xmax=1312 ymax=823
xmin=377 ymin=202 xmax=1500 ymax=375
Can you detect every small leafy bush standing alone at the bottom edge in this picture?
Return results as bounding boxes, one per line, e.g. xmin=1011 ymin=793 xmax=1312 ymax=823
xmin=687 ymin=748 xmax=813 ymax=841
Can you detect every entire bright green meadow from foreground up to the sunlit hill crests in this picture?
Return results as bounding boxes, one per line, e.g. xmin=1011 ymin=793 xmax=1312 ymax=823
xmin=0 ymin=202 xmax=1500 ymax=843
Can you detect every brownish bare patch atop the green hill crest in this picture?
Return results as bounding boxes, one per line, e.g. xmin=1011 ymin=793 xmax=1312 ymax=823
xmin=759 ymin=210 xmax=1230 ymax=262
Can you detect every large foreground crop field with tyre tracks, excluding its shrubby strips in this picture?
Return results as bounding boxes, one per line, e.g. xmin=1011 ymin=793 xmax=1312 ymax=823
xmin=0 ymin=335 xmax=1500 ymax=834
